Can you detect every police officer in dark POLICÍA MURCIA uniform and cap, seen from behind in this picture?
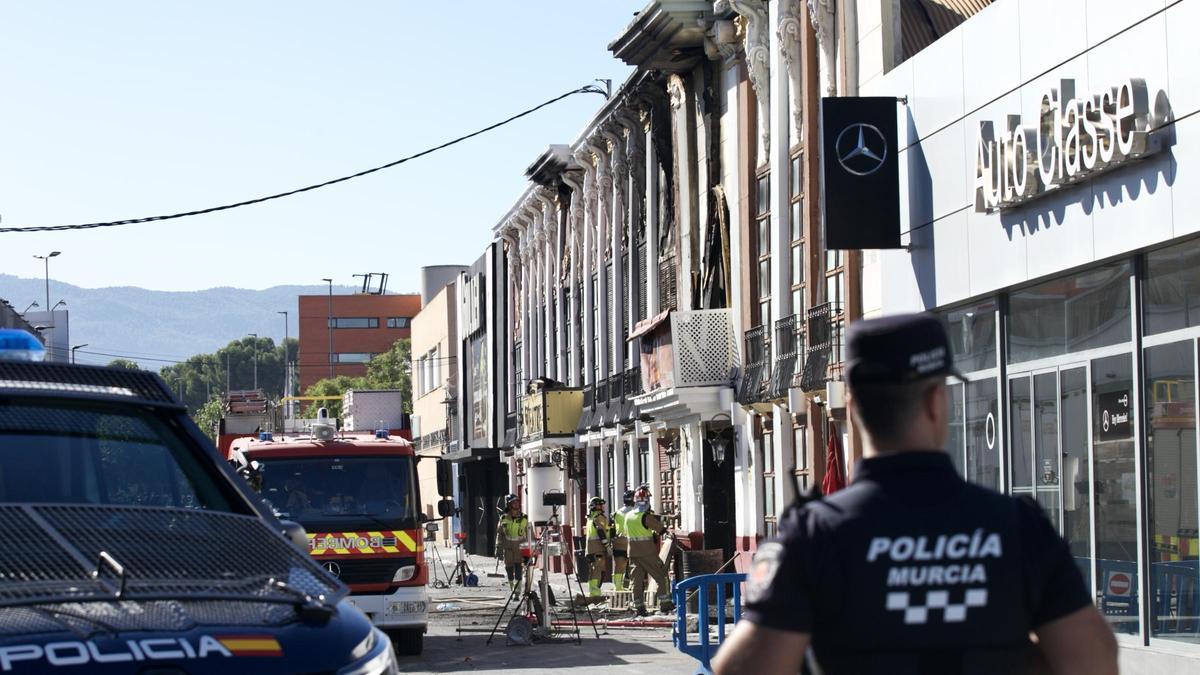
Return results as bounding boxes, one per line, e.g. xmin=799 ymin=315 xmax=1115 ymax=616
xmin=714 ymin=315 xmax=1116 ymax=675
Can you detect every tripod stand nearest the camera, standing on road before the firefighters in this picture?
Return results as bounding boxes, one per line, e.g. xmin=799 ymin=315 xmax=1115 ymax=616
xmin=487 ymin=504 xmax=600 ymax=645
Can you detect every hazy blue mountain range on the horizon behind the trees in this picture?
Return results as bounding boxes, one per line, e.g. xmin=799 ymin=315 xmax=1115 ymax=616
xmin=0 ymin=274 xmax=369 ymax=371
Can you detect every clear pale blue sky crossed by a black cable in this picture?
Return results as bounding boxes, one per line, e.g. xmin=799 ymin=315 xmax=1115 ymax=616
xmin=0 ymin=0 xmax=643 ymax=291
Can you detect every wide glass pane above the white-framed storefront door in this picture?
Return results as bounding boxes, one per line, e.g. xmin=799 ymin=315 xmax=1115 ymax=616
xmin=1008 ymin=261 xmax=1130 ymax=363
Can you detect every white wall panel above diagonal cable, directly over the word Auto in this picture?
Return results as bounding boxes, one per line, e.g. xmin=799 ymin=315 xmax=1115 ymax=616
xmin=955 ymin=0 xmax=1021 ymax=110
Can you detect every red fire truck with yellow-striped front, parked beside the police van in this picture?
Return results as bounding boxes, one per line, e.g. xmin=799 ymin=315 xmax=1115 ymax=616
xmin=230 ymin=424 xmax=430 ymax=655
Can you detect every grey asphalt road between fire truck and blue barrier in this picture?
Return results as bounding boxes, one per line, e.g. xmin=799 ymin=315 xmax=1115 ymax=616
xmin=400 ymin=540 xmax=696 ymax=675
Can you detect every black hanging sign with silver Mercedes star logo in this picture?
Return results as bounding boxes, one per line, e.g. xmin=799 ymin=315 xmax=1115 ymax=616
xmin=821 ymin=96 xmax=901 ymax=249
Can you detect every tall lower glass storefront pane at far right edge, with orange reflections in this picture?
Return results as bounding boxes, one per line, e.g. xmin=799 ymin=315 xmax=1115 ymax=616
xmin=1145 ymin=340 xmax=1200 ymax=643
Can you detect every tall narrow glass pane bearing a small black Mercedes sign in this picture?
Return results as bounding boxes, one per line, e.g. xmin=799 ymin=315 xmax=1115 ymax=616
xmin=1092 ymin=354 xmax=1141 ymax=634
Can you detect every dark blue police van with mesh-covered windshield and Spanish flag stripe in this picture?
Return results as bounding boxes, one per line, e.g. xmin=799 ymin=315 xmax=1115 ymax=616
xmin=0 ymin=330 xmax=397 ymax=675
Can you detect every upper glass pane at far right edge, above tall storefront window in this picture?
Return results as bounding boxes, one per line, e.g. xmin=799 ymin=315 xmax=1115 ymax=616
xmin=1141 ymin=240 xmax=1200 ymax=335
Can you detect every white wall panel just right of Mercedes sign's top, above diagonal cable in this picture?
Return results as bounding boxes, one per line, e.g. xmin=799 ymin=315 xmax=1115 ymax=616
xmin=908 ymin=30 xmax=964 ymax=138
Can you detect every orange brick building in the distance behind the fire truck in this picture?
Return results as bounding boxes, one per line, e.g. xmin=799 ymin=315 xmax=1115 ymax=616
xmin=298 ymin=293 xmax=421 ymax=392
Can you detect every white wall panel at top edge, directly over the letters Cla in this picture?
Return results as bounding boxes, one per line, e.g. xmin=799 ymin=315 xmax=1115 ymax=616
xmin=1019 ymin=0 xmax=1087 ymax=82
